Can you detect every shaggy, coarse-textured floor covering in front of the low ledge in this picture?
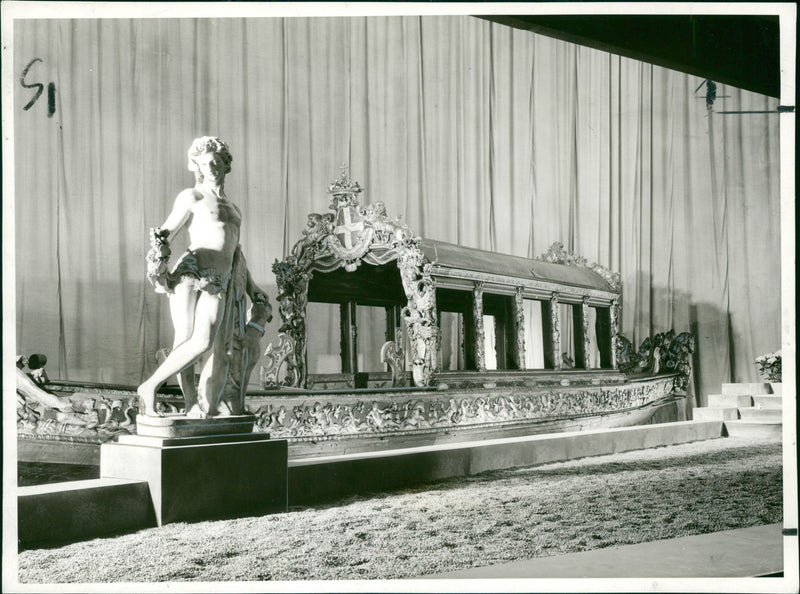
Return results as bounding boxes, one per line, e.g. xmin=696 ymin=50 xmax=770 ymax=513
xmin=18 ymin=438 xmax=782 ymax=583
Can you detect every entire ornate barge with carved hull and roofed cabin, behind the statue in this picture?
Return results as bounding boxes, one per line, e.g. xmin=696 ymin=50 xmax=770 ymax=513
xmin=18 ymin=172 xmax=694 ymax=458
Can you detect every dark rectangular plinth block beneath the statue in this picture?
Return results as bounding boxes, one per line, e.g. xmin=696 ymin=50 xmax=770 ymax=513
xmin=100 ymin=430 xmax=288 ymax=526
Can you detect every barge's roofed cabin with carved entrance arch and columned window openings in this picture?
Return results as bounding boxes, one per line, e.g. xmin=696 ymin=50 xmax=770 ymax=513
xmin=262 ymin=171 xmax=621 ymax=388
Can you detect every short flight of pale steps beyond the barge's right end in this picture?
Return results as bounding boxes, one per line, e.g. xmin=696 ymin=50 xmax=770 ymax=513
xmin=692 ymin=383 xmax=783 ymax=439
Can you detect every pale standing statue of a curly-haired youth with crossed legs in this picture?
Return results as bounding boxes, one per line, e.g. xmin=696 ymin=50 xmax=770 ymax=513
xmin=137 ymin=136 xmax=272 ymax=418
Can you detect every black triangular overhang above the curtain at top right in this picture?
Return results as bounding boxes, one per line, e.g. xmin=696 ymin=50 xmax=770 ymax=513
xmin=480 ymin=15 xmax=780 ymax=97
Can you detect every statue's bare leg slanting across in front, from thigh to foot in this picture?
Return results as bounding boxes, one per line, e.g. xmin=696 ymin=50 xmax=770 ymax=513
xmin=137 ymin=287 xmax=224 ymax=416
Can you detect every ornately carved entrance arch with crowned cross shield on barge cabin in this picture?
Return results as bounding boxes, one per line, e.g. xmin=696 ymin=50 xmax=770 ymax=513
xmin=272 ymin=170 xmax=438 ymax=387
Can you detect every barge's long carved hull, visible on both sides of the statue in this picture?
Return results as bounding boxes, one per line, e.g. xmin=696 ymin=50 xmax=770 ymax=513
xmin=17 ymin=370 xmax=680 ymax=443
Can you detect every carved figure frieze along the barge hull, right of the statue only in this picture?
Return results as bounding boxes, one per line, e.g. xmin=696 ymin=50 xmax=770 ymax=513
xmin=251 ymin=375 xmax=677 ymax=440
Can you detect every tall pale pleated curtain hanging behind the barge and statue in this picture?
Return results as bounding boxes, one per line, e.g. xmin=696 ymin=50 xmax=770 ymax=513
xmin=14 ymin=16 xmax=780 ymax=403
